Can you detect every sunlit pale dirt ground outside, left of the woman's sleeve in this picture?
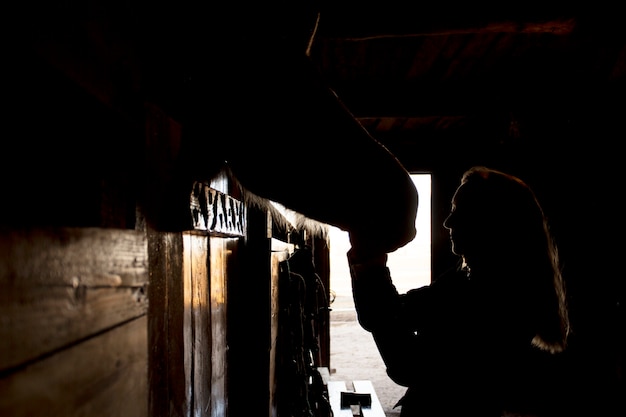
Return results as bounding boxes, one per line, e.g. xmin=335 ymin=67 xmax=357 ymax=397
xmin=330 ymin=296 xmax=405 ymax=417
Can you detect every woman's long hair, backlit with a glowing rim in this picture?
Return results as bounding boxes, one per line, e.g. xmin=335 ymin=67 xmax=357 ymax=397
xmin=461 ymin=166 xmax=570 ymax=353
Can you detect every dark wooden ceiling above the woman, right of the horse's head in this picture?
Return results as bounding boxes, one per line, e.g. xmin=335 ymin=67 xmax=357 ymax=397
xmin=310 ymin=0 xmax=626 ymax=171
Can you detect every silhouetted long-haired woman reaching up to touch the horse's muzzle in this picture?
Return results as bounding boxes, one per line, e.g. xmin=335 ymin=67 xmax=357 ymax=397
xmin=348 ymin=167 xmax=569 ymax=417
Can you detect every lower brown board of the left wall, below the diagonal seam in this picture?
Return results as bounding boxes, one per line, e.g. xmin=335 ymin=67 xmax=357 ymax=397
xmin=0 ymin=316 xmax=149 ymax=417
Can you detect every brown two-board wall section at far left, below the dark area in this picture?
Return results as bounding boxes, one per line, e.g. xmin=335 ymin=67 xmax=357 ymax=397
xmin=0 ymin=228 xmax=149 ymax=417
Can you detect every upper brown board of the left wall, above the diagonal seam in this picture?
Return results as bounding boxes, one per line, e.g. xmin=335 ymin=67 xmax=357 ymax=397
xmin=0 ymin=228 xmax=148 ymax=373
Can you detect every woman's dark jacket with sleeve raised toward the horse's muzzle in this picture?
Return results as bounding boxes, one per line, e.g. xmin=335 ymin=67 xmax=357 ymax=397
xmin=351 ymin=266 xmax=548 ymax=417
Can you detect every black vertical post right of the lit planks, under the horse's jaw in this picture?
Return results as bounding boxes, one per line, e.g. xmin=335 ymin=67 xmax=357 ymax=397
xmin=226 ymin=206 xmax=275 ymax=416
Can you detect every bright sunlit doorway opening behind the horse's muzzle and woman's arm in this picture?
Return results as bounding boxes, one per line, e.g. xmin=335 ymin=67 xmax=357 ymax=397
xmin=329 ymin=174 xmax=431 ymax=416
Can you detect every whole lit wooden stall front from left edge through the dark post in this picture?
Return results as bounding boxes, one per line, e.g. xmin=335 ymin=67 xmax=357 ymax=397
xmin=0 ymin=176 xmax=327 ymax=417
